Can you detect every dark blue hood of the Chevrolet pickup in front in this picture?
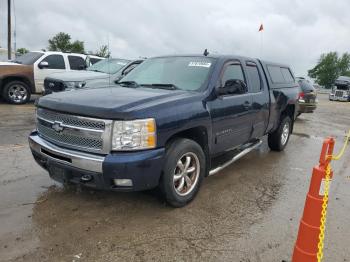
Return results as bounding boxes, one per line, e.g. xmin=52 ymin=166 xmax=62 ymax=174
xmin=37 ymin=85 xmax=199 ymax=119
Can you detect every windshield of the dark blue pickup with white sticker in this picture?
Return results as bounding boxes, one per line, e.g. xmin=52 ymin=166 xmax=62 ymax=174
xmin=121 ymin=57 xmax=215 ymax=91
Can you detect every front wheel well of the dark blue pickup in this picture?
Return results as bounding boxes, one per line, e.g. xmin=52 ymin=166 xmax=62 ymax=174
xmin=165 ymin=126 xmax=210 ymax=174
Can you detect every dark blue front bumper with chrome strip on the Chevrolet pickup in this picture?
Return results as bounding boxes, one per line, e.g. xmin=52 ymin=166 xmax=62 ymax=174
xmin=29 ymin=131 xmax=165 ymax=191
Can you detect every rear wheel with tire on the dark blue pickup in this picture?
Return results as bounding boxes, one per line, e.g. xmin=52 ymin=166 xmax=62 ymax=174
xmin=268 ymin=116 xmax=292 ymax=151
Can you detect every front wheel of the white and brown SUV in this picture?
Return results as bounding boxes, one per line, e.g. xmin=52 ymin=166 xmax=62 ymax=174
xmin=2 ymin=81 xmax=30 ymax=105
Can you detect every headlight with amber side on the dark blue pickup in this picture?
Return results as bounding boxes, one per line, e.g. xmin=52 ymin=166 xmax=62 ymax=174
xmin=112 ymin=118 xmax=156 ymax=151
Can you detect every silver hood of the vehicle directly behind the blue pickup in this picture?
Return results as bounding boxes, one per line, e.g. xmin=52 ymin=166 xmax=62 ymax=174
xmin=49 ymin=70 xmax=109 ymax=82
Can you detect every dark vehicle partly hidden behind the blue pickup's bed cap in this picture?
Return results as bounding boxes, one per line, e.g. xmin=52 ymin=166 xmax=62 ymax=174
xmin=296 ymin=77 xmax=318 ymax=116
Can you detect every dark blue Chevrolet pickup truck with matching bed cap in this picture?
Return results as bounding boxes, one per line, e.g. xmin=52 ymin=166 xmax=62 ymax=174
xmin=29 ymin=55 xmax=299 ymax=207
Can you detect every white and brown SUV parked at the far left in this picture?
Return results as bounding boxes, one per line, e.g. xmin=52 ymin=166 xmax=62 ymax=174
xmin=0 ymin=51 xmax=102 ymax=104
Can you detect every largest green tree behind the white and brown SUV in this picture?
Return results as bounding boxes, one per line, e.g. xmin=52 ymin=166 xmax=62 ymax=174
xmin=48 ymin=32 xmax=85 ymax=53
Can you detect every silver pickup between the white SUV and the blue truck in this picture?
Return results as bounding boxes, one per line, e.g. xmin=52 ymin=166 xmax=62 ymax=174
xmin=44 ymin=58 xmax=143 ymax=95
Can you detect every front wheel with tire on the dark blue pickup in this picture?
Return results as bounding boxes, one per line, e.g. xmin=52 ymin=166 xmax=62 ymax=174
xmin=160 ymin=139 xmax=205 ymax=207
